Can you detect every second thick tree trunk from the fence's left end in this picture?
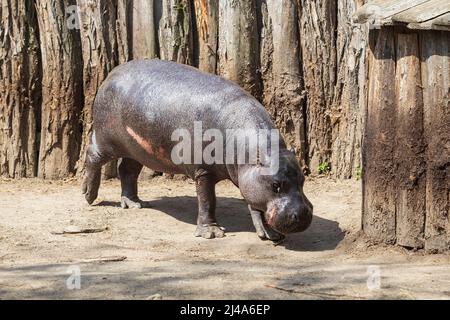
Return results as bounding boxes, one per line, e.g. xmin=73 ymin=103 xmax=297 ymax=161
xmin=36 ymin=0 xmax=83 ymax=179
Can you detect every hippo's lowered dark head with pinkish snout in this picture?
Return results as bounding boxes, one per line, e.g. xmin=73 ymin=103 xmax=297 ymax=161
xmin=239 ymin=150 xmax=313 ymax=234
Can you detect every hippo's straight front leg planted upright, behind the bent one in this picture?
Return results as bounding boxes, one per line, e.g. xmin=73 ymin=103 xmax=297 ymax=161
xmin=195 ymin=172 xmax=225 ymax=239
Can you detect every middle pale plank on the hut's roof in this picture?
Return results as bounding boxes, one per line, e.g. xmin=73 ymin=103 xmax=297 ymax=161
xmin=392 ymin=0 xmax=450 ymax=23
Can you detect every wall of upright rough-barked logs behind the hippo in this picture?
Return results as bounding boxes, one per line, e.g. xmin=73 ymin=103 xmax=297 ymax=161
xmin=0 ymin=0 xmax=367 ymax=179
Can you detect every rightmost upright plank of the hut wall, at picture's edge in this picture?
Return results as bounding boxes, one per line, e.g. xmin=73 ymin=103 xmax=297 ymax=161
xmin=420 ymin=31 xmax=450 ymax=252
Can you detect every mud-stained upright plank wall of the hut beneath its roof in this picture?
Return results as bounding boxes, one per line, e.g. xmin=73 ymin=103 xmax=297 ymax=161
xmin=362 ymin=27 xmax=450 ymax=251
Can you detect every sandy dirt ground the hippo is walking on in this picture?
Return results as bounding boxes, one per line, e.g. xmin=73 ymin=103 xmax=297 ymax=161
xmin=0 ymin=177 xmax=450 ymax=299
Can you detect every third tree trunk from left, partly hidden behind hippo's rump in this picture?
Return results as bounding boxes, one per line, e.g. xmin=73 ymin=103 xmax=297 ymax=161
xmin=78 ymin=0 xmax=121 ymax=178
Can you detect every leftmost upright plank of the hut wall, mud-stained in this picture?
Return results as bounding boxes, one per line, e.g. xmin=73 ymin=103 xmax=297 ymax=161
xmin=362 ymin=28 xmax=396 ymax=243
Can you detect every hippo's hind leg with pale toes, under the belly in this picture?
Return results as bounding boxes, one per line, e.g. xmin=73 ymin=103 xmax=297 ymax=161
xmin=118 ymin=158 xmax=142 ymax=209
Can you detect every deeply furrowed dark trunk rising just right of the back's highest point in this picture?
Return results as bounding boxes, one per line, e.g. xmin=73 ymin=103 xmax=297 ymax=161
xmin=159 ymin=0 xmax=194 ymax=64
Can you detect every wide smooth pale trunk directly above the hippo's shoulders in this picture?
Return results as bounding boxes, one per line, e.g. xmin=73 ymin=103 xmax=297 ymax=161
xmin=218 ymin=0 xmax=261 ymax=98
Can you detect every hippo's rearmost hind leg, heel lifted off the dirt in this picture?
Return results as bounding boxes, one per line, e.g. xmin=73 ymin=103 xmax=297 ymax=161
xmin=82 ymin=139 xmax=111 ymax=204
